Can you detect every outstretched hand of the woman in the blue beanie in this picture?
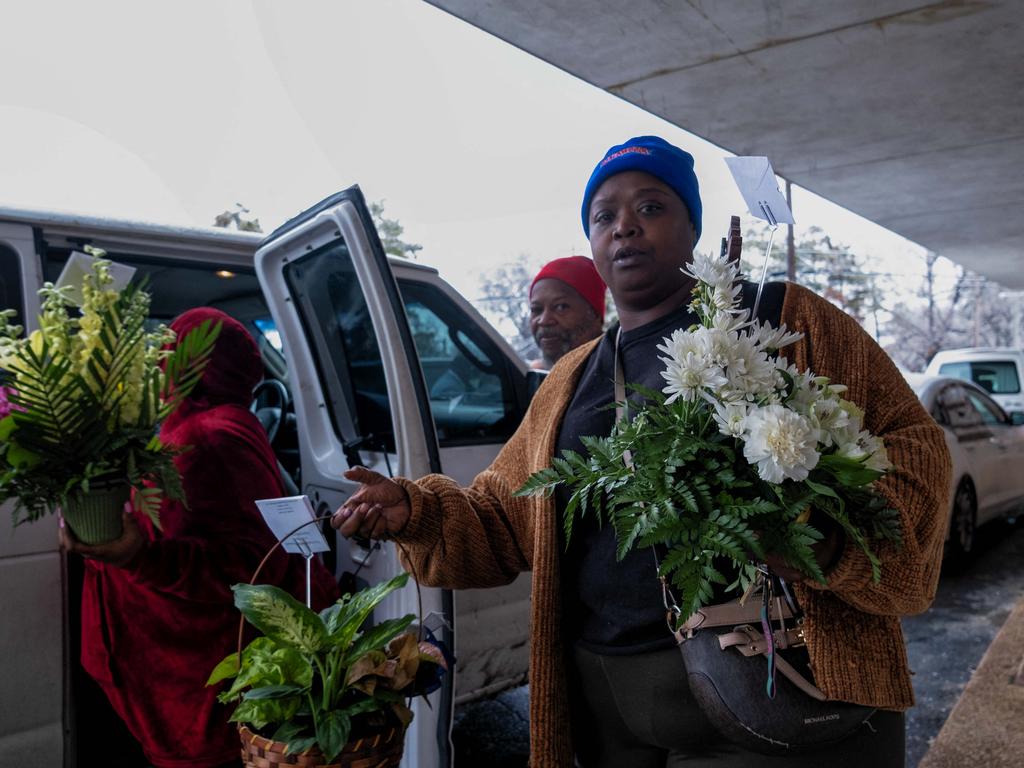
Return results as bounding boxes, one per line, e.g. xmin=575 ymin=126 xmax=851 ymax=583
xmin=331 ymin=467 xmax=412 ymax=539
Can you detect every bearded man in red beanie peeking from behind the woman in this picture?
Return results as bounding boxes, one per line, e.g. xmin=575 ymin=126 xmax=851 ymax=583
xmin=529 ymin=256 xmax=605 ymax=369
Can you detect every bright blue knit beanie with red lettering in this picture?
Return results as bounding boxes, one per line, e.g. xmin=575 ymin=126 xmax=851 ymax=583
xmin=582 ymin=136 xmax=701 ymax=244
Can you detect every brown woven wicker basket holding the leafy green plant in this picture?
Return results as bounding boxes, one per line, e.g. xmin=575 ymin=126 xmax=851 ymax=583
xmin=239 ymin=725 xmax=406 ymax=768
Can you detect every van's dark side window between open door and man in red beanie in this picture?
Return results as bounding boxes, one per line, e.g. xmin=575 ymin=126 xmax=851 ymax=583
xmin=398 ymin=281 xmax=519 ymax=447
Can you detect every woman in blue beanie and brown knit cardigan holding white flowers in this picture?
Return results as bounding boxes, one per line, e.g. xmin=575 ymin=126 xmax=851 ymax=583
xmin=332 ymin=136 xmax=949 ymax=768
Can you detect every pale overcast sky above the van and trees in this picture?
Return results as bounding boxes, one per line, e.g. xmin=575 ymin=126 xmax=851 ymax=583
xmin=0 ymin=0 xmax=942 ymax=298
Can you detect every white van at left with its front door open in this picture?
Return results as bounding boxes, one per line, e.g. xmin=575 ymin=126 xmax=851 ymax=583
xmin=0 ymin=186 xmax=536 ymax=768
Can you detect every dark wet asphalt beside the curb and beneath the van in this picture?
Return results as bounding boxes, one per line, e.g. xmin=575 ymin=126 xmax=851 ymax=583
xmin=453 ymin=518 xmax=1024 ymax=768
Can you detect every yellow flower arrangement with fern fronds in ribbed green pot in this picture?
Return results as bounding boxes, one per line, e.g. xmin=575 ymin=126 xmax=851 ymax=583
xmin=0 ymin=248 xmax=220 ymax=544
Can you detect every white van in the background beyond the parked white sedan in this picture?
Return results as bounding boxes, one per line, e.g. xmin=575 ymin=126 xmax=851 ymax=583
xmin=925 ymin=347 xmax=1024 ymax=424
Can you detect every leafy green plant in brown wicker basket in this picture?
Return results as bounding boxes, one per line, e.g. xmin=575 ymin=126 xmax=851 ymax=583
xmin=207 ymin=573 xmax=447 ymax=766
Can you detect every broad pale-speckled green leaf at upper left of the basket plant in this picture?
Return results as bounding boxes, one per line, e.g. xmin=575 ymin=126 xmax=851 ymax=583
xmin=231 ymin=584 xmax=328 ymax=653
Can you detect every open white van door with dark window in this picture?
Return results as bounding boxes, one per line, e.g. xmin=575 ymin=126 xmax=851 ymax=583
xmin=256 ymin=186 xmax=454 ymax=768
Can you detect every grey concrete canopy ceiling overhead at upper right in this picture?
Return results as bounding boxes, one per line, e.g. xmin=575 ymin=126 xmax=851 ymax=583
xmin=429 ymin=0 xmax=1024 ymax=289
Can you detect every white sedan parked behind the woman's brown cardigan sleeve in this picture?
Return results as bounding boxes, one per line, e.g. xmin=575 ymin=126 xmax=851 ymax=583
xmin=906 ymin=374 xmax=1024 ymax=565
